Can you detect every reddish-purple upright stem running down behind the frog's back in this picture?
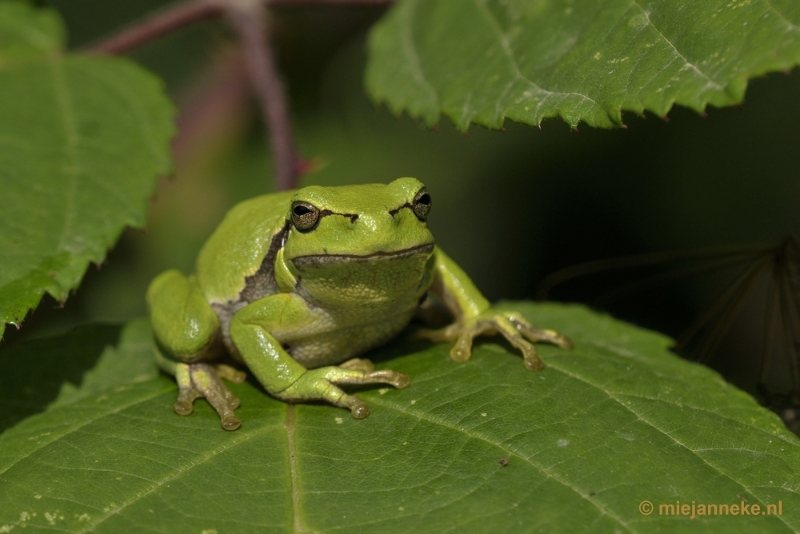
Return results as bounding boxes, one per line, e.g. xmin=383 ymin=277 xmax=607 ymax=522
xmin=225 ymin=1 xmax=298 ymax=191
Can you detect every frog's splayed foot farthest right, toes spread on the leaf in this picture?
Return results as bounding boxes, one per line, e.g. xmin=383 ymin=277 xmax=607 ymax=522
xmin=415 ymin=309 xmax=572 ymax=371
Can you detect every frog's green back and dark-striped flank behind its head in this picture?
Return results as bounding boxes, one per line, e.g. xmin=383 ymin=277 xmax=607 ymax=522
xmin=195 ymin=191 xmax=294 ymax=303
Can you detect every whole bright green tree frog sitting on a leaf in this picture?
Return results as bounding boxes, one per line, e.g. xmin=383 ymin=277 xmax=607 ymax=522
xmin=147 ymin=178 xmax=570 ymax=430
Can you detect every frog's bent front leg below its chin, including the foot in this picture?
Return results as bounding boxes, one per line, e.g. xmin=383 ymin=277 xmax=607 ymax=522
xmin=231 ymin=293 xmax=410 ymax=419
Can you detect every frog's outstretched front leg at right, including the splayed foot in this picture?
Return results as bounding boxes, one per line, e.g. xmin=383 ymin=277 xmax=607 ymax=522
xmin=418 ymin=247 xmax=572 ymax=371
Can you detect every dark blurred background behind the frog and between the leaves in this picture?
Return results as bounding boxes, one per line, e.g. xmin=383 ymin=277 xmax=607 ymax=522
xmin=17 ymin=0 xmax=800 ymax=408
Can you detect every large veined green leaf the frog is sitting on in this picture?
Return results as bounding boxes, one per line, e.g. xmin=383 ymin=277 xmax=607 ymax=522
xmin=0 ymin=304 xmax=800 ymax=532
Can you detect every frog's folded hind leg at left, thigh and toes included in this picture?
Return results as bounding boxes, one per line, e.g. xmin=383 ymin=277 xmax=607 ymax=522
xmin=147 ymin=270 xmax=246 ymax=430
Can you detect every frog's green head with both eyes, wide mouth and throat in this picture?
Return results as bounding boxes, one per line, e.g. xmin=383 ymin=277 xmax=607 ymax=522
xmin=282 ymin=178 xmax=434 ymax=304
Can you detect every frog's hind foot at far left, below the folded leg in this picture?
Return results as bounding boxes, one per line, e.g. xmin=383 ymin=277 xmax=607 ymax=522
xmin=175 ymin=363 xmax=247 ymax=430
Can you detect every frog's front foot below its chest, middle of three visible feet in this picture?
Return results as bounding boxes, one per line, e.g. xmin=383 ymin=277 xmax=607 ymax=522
xmin=276 ymin=366 xmax=411 ymax=419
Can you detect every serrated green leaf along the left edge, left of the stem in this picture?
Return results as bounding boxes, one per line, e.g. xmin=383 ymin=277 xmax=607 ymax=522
xmin=0 ymin=1 xmax=174 ymax=335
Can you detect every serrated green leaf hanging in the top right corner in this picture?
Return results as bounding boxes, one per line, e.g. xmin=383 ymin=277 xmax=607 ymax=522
xmin=366 ymin=0 xmax=800 ymax=130
